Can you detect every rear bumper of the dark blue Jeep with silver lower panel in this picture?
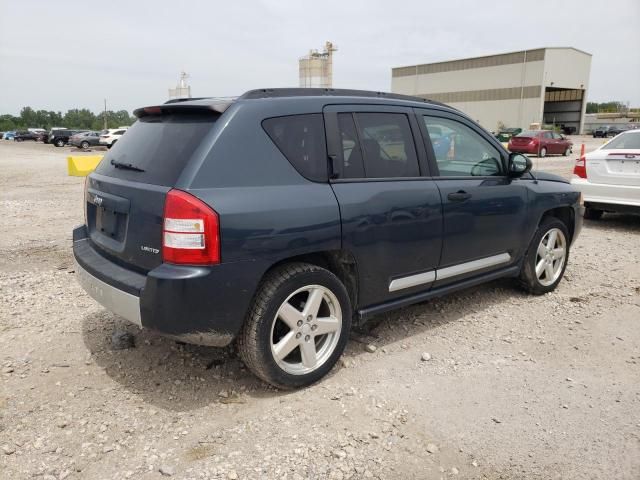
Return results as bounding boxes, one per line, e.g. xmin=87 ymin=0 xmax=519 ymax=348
xmin=73 ymin=226 xmax=266 ymax=347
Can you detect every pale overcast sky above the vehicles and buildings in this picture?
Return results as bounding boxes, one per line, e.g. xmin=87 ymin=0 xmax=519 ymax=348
xmin=0 ymin=0 xmax=640 ymax=114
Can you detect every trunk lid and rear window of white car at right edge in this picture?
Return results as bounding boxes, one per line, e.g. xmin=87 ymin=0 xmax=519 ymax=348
xmin=586 ymin=132 xmax=640 ymax=186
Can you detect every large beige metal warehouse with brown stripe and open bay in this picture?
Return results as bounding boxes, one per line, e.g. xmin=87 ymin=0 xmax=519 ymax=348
xmin=391 ymin=47 xmax=591 ymax=133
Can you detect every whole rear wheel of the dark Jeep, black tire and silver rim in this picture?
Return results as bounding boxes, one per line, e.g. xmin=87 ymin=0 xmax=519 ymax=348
xmin=238 ymin=263 xmax=351 ymax=389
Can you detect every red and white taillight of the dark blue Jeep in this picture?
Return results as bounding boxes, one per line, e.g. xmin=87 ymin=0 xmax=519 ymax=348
xmin=162 ymin=190 xmax=220 ymax=265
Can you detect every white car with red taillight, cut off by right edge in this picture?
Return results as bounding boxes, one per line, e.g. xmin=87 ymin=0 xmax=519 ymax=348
xmin=571 ymin=129 xmax=640 ymax=220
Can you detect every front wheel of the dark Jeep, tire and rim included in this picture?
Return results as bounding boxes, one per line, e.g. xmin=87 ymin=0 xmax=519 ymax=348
xmin=520 ymin=217 xmax=569 ymax=295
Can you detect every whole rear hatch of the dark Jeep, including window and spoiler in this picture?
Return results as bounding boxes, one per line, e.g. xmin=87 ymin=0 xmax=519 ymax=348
xmin=85 ymin=109 xmax=220 ymax=273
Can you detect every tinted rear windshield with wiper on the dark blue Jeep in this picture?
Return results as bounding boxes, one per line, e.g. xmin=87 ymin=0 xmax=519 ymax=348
xmin=96 ymin=114 xmax=219 ymax=187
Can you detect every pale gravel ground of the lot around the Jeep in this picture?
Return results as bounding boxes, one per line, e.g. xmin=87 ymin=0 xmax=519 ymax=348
xmin=0 ymin=137 xmax=640 ymax=480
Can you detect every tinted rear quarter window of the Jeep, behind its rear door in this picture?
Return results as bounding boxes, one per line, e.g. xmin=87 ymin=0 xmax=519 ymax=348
xmin=262 ymin=113 xmax=327 ymax=182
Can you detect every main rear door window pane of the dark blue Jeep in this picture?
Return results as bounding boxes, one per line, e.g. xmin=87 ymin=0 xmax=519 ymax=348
xmin=355 ymin=113 xmax=420 ymax=178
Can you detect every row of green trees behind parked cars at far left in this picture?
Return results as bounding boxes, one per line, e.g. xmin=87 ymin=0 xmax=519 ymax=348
xmin=0 ymin=107 xmax=136 ymax=132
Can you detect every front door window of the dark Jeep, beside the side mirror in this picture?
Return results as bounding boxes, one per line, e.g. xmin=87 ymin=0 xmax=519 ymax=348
xmin=423 ymin=116 xmax=505 ymax=177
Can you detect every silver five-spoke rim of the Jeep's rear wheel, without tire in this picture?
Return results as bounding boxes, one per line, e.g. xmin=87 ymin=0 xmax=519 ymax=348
xmin=271 ymin=285 xmax=342 ymax=375
